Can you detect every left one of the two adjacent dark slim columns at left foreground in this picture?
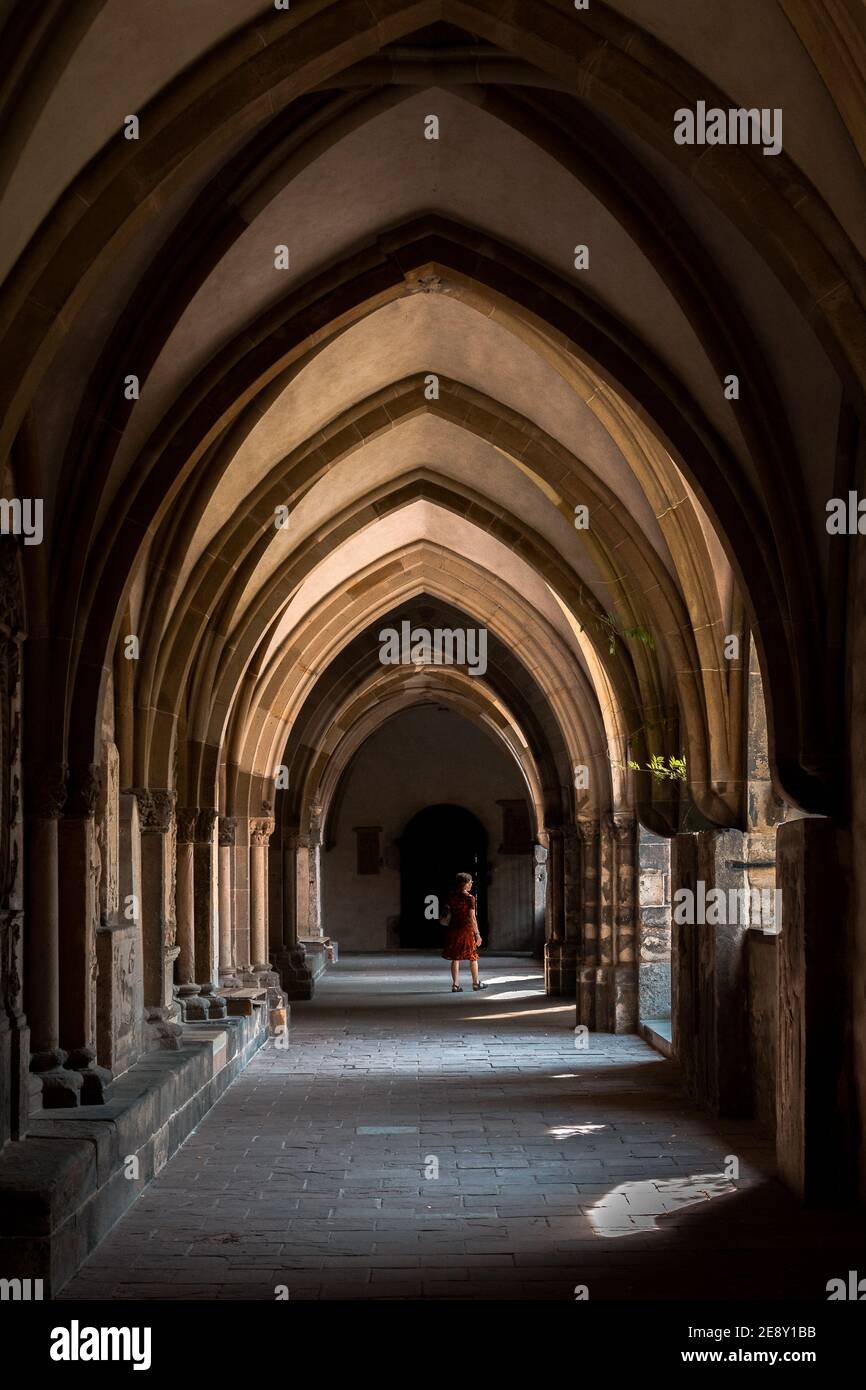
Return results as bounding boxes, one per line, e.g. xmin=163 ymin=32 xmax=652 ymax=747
xmin=25 ymin=763 xmax=83 ymax=1109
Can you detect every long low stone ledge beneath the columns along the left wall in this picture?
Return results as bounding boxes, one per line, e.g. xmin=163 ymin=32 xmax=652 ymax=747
xmin=0 ymin=1008 xmax=267 ymax=1298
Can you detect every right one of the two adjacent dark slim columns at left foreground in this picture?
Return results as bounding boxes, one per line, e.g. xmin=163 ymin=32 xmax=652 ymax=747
xmin=58 ymin=766 xmax=111 ymax=1105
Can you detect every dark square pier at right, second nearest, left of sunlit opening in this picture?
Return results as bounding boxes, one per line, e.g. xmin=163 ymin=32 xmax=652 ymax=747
xmin=671 ymin=830 xmax=752 ymax=1116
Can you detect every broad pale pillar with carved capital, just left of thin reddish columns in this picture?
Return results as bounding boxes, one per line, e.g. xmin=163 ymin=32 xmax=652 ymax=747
xmin=135 ymin=788 xmax=181 ymax=1045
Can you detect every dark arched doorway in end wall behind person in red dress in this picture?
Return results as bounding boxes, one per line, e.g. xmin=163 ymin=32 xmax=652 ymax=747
xmin=400 ymin=805 xmax=487 ymax=949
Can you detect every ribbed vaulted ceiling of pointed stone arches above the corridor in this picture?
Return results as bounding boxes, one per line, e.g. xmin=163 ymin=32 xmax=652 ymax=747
xmin=0 ymin=0 xmax=866 ymax=824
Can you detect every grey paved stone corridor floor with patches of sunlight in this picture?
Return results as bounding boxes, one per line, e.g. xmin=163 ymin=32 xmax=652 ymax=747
xmin=61 ymin=955 xmax=866 ymax=1300
